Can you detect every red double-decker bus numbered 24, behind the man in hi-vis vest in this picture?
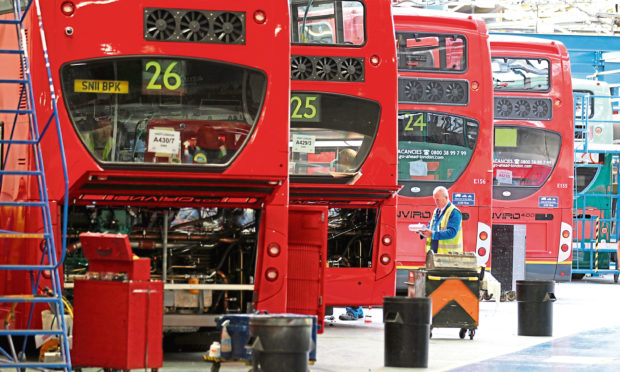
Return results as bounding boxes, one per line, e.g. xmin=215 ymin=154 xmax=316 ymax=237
xmin=394 ymin=8 xmax=493 ymax=292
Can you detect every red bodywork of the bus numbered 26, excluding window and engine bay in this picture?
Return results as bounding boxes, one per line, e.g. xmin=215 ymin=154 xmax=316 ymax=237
xmin=0 ymin=0 xmax=290 ymax=324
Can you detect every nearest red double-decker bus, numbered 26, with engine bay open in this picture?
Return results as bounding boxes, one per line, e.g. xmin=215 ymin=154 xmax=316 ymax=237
xmin=0 ymin=0 xmax=290 ymax=327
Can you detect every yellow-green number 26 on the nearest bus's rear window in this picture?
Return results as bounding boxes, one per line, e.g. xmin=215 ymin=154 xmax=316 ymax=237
xmin=142 ymin=60 xmax=185 ymax=94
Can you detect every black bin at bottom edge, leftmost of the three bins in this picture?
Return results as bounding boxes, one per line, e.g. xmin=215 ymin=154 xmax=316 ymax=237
xmin=248 ymin=314 xmax=313 ymax=372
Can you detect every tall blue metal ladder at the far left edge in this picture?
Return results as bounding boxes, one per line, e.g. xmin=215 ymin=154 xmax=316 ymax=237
xmin=0 ymin=0 xmax=71 ymax=371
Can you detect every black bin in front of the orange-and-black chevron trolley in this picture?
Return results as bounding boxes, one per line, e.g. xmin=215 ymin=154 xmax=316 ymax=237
xmin=383 ymin=297 xmax=431 ymax=368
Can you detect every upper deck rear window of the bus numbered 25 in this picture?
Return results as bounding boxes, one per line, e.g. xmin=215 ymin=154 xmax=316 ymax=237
xmin=291 ymin=0 xmax=366 ymax=46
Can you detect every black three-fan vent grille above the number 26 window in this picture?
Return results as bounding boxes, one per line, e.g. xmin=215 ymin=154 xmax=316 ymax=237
xmin=144 ymin=8 xmax=246 ymax=44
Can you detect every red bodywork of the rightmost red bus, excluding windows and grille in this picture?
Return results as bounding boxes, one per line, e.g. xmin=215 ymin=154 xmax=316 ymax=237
xmin=491 ymin=35 xmax=574 ymax=281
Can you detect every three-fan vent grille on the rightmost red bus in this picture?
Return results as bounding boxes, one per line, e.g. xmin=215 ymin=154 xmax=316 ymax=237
xmin=494 ymin=96 xmax=553 ymax=120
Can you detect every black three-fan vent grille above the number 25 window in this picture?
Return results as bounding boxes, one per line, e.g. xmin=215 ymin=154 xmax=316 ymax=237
xmin=291 ymin=56 xmax=364 ymax=82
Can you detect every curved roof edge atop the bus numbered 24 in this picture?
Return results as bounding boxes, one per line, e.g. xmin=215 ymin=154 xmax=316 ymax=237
xmin=392 ymin=7 xmax=487 ymax=34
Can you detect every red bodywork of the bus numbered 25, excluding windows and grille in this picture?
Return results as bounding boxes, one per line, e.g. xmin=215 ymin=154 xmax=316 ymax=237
xmin=290 ymin=0 xmax=398 ymax=306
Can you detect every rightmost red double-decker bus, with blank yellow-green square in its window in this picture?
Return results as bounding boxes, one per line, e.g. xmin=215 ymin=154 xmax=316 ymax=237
xmin=491 ymin=36 xmax=574 ymax=291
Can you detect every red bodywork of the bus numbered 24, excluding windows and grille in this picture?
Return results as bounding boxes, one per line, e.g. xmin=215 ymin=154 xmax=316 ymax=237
xmin=394 ymin=8 xmax=493 ymax=289
